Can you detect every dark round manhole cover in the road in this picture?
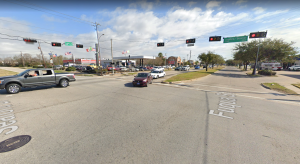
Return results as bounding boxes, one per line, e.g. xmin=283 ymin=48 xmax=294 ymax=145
xmin=0 ymin=135 xmax=31 ymax=153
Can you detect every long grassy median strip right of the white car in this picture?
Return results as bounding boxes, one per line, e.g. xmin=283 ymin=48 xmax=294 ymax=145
xmin=166 ymin=67 xmax=223 ymax=82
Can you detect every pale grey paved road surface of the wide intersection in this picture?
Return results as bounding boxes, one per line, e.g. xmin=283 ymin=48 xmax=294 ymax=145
xmin=0 ymin=67 xmax=300 ymax=164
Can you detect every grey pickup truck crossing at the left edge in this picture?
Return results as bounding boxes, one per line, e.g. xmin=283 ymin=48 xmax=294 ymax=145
xmin=0 ymin=68 xmax=76 ymax=94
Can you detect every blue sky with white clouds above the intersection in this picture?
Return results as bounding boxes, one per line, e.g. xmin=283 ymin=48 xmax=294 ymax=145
xmin=0 ymin=0 xmax=300 ymax=59
